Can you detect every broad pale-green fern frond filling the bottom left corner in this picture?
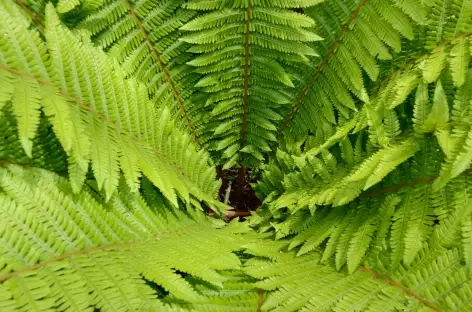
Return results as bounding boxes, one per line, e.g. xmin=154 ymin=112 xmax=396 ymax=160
xmin=0 ymin=165 xmax=251 ymax=310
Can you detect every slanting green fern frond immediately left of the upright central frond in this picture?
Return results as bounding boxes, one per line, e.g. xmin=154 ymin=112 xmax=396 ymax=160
xmin=79 ymin=0 xmax=204 ymax=142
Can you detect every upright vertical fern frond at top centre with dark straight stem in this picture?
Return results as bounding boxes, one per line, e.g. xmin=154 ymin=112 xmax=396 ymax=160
xmin=181 ymin=1 xmax=321 ymax=168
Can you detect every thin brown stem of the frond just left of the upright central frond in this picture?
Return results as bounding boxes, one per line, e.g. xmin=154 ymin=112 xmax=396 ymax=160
xmin=123 ymin=0 xmax=199 ymax=145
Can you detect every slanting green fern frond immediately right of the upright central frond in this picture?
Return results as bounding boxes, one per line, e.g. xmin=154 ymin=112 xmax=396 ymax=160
xmin=280 ymin=0 xmax=426 ymax=141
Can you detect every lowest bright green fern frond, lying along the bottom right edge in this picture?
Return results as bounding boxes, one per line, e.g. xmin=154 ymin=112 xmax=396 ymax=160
xmin=246 ymin=240 xmax=471 ymax=311
